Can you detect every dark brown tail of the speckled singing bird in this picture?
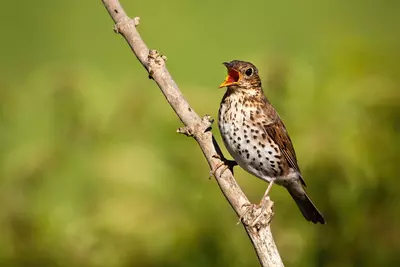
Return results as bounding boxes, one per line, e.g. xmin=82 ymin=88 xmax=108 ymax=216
xmin=288 ymin=187 xmax=325 ymax=224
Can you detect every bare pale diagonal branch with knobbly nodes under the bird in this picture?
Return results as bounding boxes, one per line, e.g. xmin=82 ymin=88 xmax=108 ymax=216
xmin=102 ymin=0 xmax=283 ymax=267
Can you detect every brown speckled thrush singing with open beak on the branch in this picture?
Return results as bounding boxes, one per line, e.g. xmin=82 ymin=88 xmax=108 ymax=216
xmin=218 ymin=60 xmax=325 ymax=224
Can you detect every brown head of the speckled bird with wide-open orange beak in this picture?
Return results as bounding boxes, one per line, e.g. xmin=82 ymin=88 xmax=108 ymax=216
xmin=219 ymin=60 xmax=261 ymax=89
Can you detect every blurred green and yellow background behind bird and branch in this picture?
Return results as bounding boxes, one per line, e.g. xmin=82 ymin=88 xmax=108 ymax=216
xmin=0 ymin=0 xmax=400 ymax=267
